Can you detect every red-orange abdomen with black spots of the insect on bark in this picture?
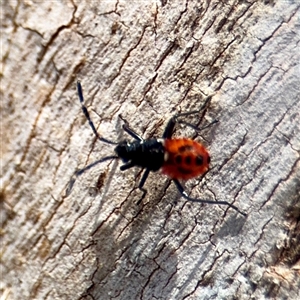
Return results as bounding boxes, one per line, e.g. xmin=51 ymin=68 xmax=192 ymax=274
xmin=161 ymin=138 xmax=210 ymax=180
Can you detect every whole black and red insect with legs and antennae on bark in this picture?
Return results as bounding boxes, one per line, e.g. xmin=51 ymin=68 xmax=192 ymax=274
xmin=66 ymin=81 xmax=246 ymax=216
